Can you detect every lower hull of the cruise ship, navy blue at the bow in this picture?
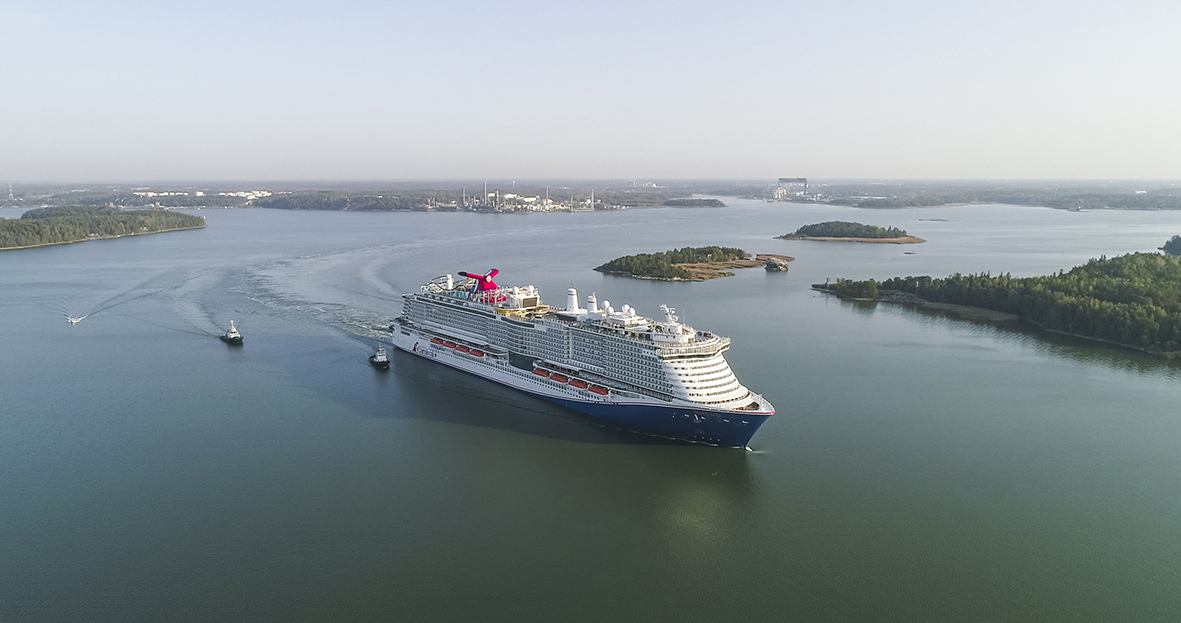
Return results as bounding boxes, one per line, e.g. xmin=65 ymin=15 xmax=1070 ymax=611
xmin=393 ymin=332 xmax=775 ymax=448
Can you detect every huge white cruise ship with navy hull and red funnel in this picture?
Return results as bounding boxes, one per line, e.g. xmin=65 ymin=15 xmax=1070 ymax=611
xmin=390 ymin=270 xmax=775 ymax=447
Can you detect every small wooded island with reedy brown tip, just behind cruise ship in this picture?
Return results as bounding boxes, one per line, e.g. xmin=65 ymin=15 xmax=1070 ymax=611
xmin=595 ymin=247 xmax=794 ymax=281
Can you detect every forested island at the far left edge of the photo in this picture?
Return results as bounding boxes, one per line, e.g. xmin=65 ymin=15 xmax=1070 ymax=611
xmin=0 ymin=206 xmax=205 ymax=250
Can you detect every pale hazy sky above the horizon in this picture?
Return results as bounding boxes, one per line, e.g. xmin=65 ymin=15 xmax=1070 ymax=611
xmin=0 ymin=0 xmax=1181 ymax=183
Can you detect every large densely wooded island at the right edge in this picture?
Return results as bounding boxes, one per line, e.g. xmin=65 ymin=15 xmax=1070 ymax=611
xmin=813 ymin=253 xmax=1181 ymax=359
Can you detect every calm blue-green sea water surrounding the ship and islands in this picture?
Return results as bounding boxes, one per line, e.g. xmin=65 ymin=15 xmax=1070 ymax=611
xmin=0 ymin=199 xmax=1181 ymax=622
